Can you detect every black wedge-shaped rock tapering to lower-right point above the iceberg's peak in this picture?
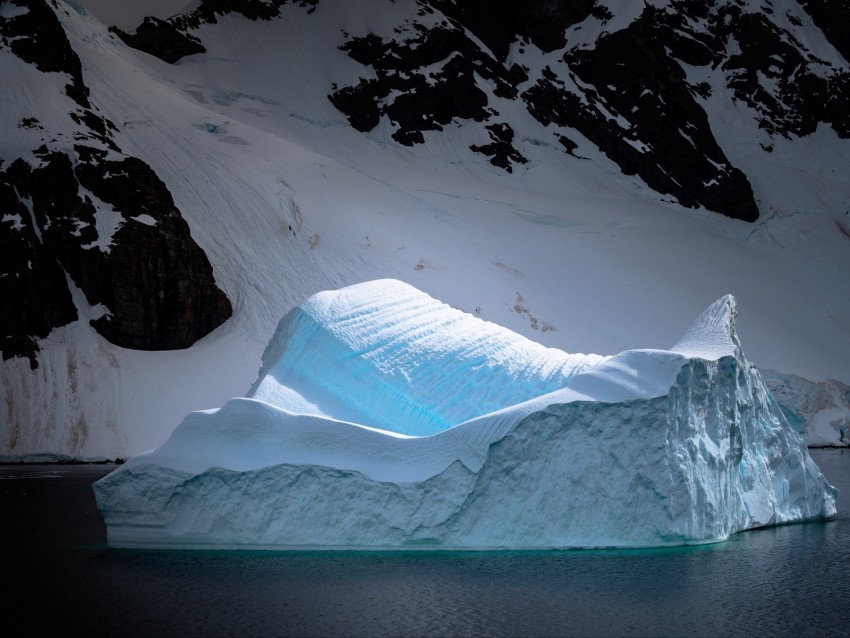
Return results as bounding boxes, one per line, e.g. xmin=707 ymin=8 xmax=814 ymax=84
xmin=523 ymin=7 xmax=758 ymax=221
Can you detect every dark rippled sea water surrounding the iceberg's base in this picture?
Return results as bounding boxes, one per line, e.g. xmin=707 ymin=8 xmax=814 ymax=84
xmin=0 ymin=450 xmax=850 ymax=637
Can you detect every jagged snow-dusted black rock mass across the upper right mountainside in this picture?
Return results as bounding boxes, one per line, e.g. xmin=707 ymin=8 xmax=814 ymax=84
xmin=322 ymin=0 xmax=850 ymax=221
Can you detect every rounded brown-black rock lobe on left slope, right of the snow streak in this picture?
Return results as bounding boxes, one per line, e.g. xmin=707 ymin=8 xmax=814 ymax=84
xmin=76 ymin=157 xmax=232 ymax=350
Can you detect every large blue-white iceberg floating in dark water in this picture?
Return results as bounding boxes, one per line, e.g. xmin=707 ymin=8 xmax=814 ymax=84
xmin=94 ymin=280 xmax=836 ymax=549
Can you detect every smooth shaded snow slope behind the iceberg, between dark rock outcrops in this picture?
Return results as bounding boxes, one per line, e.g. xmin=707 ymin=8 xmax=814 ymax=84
xmin=0 ymin=0 xmax=850 ymax=458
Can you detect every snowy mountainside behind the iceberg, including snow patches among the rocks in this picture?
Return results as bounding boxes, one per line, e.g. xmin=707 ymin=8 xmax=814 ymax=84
xmin=0 ymin=0 xmax=850 ymax=457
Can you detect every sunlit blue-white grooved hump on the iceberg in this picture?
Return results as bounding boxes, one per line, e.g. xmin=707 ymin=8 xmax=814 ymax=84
xmin=249 ymin=279 xmax=602 ymax=436
